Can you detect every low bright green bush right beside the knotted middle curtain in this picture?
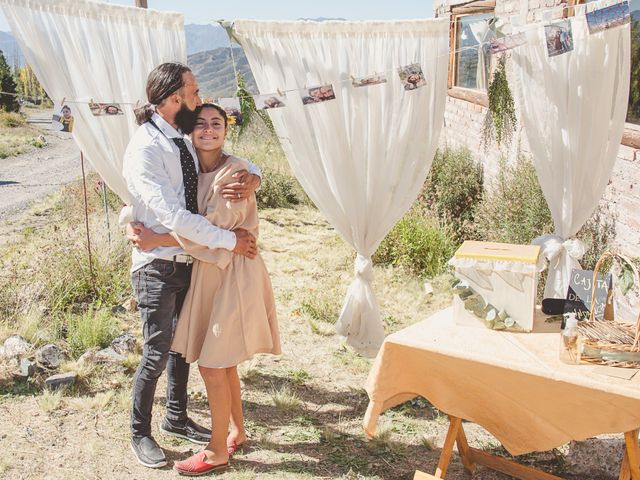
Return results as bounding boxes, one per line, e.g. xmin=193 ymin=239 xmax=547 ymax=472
xmin=373 ymin=208 xmax=457 ymax=277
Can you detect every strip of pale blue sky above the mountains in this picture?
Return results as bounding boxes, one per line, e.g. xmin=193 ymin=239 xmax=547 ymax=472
xmin=0 ymin=0 xmax=433 ymax=31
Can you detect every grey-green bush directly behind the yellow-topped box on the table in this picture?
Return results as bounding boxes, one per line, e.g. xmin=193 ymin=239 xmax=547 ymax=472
xmin=475 ymin=155 xmax=553 ymax=244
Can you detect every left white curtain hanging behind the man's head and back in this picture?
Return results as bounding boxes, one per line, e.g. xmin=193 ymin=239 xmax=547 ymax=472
xmin=0 ymin=0 xmax=187 ymax=201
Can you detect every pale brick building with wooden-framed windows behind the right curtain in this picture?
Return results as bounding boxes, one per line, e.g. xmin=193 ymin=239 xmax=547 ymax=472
xmin=434 ymin=0 xmax=640 ymax=257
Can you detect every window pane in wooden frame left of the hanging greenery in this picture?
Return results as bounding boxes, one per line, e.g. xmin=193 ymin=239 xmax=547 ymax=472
xmin=451 ymin=12 xmax=492 ymax=92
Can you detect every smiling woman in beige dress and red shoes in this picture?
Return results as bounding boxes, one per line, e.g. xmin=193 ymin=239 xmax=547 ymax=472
xmin=140 ymin=104 xmax=280 ymax=475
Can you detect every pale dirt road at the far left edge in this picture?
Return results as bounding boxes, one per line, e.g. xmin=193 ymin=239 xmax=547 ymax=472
xmin=0 ymin=112 xmax=81 ymax=244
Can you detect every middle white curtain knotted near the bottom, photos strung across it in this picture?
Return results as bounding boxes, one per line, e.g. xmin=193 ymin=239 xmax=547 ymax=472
xmin=234 ymin=20 xmax=449 ymax=356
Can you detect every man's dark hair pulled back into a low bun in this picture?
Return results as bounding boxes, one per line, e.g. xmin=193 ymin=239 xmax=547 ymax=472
xmin=135 ymin=62 xmax=191 ymax=125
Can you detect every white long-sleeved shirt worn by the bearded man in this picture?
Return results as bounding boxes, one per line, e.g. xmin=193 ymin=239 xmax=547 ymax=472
xmin=122 ymin=113 xmax=260 ymax=272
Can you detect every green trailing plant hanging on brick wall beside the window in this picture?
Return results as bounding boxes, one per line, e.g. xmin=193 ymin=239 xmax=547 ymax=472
xmin=480 ymin=55 xmax=518 ymax=150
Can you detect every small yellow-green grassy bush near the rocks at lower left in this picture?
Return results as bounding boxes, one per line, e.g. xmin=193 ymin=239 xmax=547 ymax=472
xmin=64 ymin=309 xmax=120 ymax=358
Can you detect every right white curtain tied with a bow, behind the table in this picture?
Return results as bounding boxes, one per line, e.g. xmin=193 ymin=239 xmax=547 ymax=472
xmin=513 ymin=15 xmax=630 ymax=298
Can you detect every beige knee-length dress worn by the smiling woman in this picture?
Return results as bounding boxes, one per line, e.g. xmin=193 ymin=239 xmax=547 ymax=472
xmin=171 ymin=156 xmax=280 ymax=368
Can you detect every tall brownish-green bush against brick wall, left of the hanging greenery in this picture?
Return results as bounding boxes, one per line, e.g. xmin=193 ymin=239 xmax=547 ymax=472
xmin=420 ymin=148 xmax=483 ymax=241
